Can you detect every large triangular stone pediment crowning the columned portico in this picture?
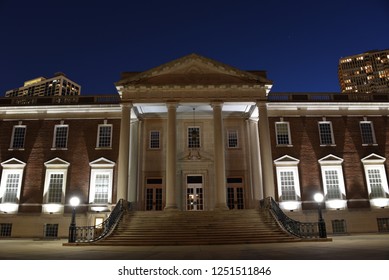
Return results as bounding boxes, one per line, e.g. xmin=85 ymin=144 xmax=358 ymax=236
xmin=116 ymin=54 xmax=272 ymax=87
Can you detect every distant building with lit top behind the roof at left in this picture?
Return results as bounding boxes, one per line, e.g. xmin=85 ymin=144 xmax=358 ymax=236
xmin=5 ymin=73 xmax=81 ymax=97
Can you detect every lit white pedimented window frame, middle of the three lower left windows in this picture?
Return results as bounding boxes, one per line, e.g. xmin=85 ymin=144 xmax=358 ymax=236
xmin=42 ymin=157 xmax=70 ymax=213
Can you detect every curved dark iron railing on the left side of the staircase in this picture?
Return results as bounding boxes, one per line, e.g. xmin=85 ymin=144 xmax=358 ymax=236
xmin=76 ymin=199 xmax=131 ymax=243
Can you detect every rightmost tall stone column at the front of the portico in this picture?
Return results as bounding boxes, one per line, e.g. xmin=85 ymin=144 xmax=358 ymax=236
xmin=257 ymin=101 xmax=275 ymax=198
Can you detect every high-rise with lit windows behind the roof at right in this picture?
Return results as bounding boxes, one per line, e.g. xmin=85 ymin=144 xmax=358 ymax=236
xmin=338 ymin=50 xmax=389 ymax=93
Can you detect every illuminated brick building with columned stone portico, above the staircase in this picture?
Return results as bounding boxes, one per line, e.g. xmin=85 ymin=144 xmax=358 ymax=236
xmin=0 ymin=54 xmax=389 ymax=237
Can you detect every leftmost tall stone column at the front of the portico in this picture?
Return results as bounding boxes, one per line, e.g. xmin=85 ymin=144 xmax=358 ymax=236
xmin=116 ymin=103 xmax=132 ymax=201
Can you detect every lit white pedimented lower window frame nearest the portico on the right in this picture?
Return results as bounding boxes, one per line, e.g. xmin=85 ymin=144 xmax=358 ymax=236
xmin=274 ymin=155 xmax=301 ymax=211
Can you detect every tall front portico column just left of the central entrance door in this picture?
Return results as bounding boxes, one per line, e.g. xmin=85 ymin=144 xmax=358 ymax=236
xmin=165 ymin=102 xmax=178 ymax=210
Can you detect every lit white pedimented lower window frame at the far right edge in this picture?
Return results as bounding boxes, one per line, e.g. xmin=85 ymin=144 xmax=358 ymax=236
xmin=361 ymin=153 xmax=389 ymax=208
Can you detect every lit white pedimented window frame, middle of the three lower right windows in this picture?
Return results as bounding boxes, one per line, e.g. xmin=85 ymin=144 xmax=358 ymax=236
xmin=318 ymin=154 xmax=347 ymax=209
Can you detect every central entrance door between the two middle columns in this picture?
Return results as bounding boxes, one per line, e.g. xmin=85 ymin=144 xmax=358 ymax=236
xmin=186 ymin=175 xmax=204 ymax=211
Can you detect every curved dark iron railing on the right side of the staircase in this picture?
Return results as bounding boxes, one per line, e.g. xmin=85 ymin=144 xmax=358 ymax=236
xmin=260 ymin=197 xmax=319 ymax=238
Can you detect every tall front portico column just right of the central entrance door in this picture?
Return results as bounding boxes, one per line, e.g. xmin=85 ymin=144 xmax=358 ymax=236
xmin=211 ymin=102 xmax=228 ymax=210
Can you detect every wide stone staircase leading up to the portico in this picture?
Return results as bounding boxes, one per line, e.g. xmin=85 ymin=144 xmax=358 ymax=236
xmin=94 ymin=209 xmax=301 ymax=246
